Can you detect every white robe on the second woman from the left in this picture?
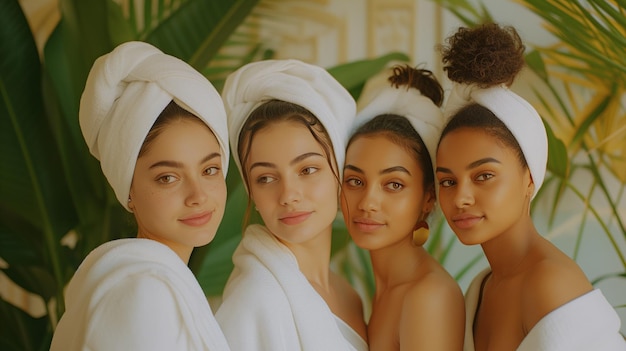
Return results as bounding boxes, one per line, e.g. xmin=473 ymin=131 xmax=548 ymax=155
xmin=216 ymin=225 xmax=367 ymax=351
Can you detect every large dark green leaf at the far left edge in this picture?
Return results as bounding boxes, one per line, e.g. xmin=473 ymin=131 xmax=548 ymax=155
xmin=0 ymin=1 xmax=76 ymax=308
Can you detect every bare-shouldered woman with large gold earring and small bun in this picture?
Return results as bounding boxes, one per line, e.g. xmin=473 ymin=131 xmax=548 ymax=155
xmin=342 ymin=66 xmax=465 ymax=351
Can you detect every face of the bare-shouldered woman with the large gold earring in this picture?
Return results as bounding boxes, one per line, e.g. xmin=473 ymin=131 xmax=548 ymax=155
xmin=341 ymin=134 xmax=434 ymax=250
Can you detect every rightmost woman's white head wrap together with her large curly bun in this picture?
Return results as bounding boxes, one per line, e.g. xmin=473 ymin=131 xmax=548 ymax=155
xmin=443 ymin=23 xmax=548 ymax=198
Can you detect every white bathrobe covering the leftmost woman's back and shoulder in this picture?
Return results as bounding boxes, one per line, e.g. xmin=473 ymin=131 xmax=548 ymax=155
xmin=50 ymin=239 xmax=229 ymax=351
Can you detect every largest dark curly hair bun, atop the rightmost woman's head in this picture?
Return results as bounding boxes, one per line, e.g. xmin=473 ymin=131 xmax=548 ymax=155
xmin=441 ymin=23 xmax=525 ymax=88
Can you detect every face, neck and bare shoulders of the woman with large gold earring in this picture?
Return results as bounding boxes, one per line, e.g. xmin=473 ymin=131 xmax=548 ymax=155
xmin=341 ymin=133 xmax=465 ymax=351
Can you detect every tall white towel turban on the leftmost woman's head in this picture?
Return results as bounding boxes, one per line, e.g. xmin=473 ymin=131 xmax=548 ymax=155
xmin=79 ymin=42 xmax=229 ymax=211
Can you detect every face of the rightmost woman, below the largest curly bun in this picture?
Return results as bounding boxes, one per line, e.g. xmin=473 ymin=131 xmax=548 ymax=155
xmin=436 ymin=127 xmax=533 ymax=245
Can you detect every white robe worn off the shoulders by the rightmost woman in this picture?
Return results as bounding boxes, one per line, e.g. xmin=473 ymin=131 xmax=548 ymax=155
xmin=464 ymin=269 xmax=626 ymax=351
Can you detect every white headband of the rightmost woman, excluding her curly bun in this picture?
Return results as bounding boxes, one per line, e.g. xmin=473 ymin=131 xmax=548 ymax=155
xmin=444 ymin=83 xmax=548 ymax=198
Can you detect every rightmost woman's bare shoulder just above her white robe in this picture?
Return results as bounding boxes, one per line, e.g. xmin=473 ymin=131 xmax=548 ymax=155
xmin=521 ymin=248 xmax=593 ymax=332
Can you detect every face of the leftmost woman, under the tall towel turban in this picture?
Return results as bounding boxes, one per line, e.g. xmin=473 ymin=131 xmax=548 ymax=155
xmin=129 ymin=118 xmax=226 ymax=262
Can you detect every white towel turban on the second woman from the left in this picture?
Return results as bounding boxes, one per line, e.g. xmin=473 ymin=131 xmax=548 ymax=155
xmin=222 ymin=59 xmax=356 ymax=186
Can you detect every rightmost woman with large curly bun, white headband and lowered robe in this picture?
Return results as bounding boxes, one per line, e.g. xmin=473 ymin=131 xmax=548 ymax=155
xmin=436 ymin=24 xmax=626 ymax=350
